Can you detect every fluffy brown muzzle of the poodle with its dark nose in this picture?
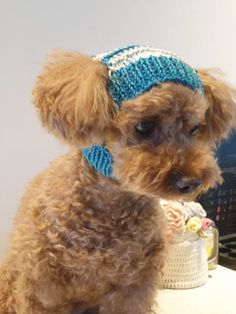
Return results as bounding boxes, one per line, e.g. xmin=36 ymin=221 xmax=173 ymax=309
xmin=115 ymin=148 xmax=222 ymax=200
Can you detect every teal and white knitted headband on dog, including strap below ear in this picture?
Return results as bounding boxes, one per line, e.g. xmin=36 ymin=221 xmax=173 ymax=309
xmin=82 ymin=45 xmax=204 ymax=177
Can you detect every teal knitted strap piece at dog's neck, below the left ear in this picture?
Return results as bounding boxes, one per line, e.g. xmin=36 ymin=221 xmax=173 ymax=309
xmin=82 ymin=145 xmax=112 ymax=177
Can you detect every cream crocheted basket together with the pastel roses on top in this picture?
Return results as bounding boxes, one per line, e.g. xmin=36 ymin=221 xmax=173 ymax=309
xmin=160 ymin=200 xmax=209 ymax=289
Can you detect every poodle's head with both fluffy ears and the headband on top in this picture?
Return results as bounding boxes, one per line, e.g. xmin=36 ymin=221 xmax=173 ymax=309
xmin=33 ymin=47 xmax=236 ymax=199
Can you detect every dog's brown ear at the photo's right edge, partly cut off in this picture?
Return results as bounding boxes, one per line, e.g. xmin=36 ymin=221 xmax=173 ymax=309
xmin=198 ymin=70 xmax=236 ymax=144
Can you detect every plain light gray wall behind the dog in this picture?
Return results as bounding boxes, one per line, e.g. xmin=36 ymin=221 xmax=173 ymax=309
xmin=0 ymin=0 xmax=236 ymax=256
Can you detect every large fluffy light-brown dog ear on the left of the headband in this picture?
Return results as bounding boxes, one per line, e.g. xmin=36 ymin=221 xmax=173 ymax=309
xmin=33 ymin=51 xmax=114 ymax=146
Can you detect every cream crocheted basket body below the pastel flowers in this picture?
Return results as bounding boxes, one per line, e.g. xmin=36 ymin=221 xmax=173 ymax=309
xmin=162 ymin=238 xmax=208 ymax=289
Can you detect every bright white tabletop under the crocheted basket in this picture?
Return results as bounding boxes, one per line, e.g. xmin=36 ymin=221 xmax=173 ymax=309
xmin=158 ymin=266 xmax=236 ymax=314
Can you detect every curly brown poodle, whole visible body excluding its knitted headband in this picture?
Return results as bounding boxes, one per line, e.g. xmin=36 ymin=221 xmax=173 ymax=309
xmin=0 ymin=47 xmax=236 ymax=314
